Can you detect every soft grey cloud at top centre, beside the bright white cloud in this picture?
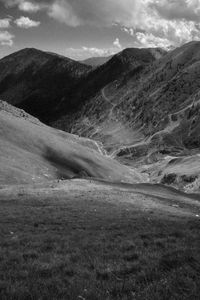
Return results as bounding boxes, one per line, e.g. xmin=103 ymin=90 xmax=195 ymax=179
xmin=49 ymin=0 xmax=141 ymax=27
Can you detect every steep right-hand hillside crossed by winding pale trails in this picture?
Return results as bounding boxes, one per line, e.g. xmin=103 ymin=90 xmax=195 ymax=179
xmin=53 ymin=42 xmax=200 ymax=150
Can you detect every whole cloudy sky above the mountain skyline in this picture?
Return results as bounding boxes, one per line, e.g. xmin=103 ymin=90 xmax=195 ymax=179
xmin=0 ymin=0 xmax=200 ymax=60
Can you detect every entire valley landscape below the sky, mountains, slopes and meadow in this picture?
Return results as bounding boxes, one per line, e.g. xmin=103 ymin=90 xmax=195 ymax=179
xmin=0 ymin=42 xmax=200 ymax=300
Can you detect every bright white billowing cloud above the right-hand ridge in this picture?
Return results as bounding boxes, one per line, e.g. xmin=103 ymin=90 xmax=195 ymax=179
xmin=119 ymin=0 xmax=200 ymax=49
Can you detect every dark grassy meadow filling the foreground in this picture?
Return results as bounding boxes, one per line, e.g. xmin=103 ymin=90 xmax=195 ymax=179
xmin=0 ymin=193 xmax=200 ymax=300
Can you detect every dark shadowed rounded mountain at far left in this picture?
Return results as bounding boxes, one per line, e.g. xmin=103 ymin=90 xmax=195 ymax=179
xmin=0 ymin=48 xmax=91 ymax=120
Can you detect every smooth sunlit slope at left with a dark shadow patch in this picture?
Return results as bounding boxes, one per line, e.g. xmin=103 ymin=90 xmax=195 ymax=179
xmin=0 ymin=103 xmax=141 ymax=184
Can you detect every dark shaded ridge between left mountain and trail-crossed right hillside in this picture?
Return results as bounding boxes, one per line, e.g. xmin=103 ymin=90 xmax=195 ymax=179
xmin=57 ymin=48 xmax=166 ymax=119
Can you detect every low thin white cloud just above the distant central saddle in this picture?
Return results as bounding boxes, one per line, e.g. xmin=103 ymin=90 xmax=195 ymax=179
xmin=65 ymin=38 xmax=122 ymax=60
